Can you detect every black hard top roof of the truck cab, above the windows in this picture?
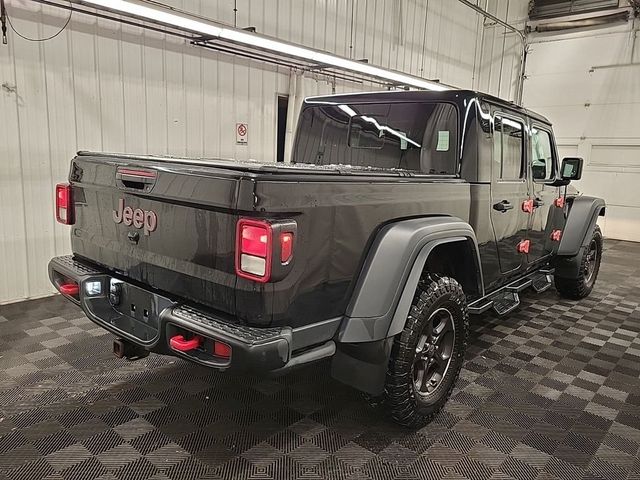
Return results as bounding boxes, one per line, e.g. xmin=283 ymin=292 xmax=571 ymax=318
xmin=305 ymin=89 xmax=551 ymax=125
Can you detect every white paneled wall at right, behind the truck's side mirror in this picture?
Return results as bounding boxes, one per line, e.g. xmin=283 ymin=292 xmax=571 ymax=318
xmin=524 ymin=22 xmax=640 ymax=241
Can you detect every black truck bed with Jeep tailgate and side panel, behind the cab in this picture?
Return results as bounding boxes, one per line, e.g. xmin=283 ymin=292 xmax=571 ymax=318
xmin=69 ymin=152 xmax=470 ymax=327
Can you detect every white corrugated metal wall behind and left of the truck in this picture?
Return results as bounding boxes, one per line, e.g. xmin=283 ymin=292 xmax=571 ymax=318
xmin=0 ymin=0 xmax=490 ymax=303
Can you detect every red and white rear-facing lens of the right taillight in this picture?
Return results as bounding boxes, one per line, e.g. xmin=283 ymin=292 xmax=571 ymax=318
xmin=236 ymin=219 xmax=273 ymax=283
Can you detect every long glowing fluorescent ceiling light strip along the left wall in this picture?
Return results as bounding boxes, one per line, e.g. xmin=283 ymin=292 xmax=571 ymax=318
xmin=81 ymin=0 xmax=449 ymax=91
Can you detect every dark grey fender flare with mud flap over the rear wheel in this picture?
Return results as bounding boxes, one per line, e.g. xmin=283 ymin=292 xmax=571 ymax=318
xmin=332 ymin=216 xmax=484 ymax=395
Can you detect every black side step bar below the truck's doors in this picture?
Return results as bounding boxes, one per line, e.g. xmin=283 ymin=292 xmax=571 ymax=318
xmin=468 ymin=268 xmax=553 ymax=316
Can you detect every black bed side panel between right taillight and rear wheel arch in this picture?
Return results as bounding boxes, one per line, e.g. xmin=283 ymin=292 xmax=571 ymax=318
xmin=252 ymin=177 xmax=470 ymax=327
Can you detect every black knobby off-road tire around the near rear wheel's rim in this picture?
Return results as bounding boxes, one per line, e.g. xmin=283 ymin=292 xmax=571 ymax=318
xmin=384 ymin=275 xmax=469 ymax=428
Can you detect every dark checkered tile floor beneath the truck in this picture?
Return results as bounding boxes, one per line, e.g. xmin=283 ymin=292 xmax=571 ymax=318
xmin=0 ymin=241 xmax=640 ymax=480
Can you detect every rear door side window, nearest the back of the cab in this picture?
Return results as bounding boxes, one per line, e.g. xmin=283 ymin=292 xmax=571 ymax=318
xmin=493 ymin=115 xmax=524 ymax=180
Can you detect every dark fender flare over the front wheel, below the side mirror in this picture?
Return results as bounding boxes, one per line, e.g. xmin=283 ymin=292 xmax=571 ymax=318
xmin=552 ymin=196 xmax=606 ymax=278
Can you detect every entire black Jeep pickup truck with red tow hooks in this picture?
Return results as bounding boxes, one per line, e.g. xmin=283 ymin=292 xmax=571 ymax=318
xmin=49 ymin=90 xmax=605 ymax=426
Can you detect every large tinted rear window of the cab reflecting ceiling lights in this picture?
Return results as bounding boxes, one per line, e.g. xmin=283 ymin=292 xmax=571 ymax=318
xmin=293 ymin=102 xmax=458 ymax=176
